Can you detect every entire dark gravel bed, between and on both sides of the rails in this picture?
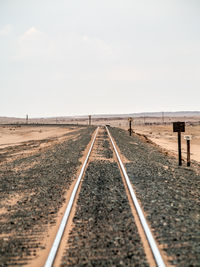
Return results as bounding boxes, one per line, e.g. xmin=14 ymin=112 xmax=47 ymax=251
xmin=0 ymin=127 xmax=200 ymax=266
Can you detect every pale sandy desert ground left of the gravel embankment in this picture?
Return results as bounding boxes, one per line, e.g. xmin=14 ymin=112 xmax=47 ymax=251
xmin=0 ymin=125 xmax=81 ymax=164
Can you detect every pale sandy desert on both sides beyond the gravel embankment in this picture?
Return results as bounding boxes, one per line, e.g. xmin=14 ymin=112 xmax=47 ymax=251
xmin=0 ymin=120 xmax=200 ymax=162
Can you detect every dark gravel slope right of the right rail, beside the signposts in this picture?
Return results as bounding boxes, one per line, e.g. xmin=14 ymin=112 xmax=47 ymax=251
xmin=110 ymin=128 xmax=200 ymax=266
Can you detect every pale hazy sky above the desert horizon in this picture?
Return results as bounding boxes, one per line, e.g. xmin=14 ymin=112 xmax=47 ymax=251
xmin=0 ymin=0 xmax=200 ymax=117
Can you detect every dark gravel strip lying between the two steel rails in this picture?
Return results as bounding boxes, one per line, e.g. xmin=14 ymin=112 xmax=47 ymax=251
xmin=62 ymin=130 xmax=148 ymax=266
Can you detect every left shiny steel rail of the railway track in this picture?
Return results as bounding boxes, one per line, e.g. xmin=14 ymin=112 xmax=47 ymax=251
xmin=44 ymin=127 xmax=99 ymax=267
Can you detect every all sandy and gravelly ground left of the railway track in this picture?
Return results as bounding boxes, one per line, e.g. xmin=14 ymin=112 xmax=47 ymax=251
xmin=0 ymin=125 xmax=94 ymax=266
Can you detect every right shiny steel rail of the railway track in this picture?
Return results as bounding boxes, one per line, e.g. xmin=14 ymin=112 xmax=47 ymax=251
xmin=106 ymin=127 xmax=166 ymax=267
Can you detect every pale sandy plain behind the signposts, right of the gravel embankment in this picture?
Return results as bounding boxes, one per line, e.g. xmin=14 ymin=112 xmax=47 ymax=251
xmin=78 ymin=117 xmax=200 ymax=162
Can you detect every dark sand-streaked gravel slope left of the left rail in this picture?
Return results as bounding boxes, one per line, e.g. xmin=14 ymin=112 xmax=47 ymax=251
xmin=0 ymin=127 xmax=95 ymax=266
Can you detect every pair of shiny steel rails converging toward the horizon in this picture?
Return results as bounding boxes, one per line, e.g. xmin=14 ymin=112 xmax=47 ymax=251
xmin=44 ymin=127 xmax=166 ymax=267
